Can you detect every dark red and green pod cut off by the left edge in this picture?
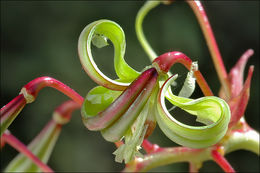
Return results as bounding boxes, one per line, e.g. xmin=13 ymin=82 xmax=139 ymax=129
xmin=0 ymin=94 xmax=26 ymax=136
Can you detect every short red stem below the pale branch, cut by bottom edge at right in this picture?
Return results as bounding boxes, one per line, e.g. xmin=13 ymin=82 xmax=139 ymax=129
xmin=211 ymin=150 xmax=235 ymax=172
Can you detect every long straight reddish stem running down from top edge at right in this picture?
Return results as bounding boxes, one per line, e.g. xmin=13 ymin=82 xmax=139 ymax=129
xmin=187 ymin=0 xmax=230 ymax=97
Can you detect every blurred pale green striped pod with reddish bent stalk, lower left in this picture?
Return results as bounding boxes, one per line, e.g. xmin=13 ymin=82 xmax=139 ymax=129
xmin=5 ymin=100 xmax=80 ymax=172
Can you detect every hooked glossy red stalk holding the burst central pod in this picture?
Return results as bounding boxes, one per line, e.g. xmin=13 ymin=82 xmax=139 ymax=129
xmin=153 ymin=51 xmax=213 ymax=96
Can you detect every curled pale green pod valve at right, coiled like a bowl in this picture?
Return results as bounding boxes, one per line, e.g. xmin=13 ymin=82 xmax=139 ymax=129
xmin=156 ymin=75 xmax=230 ymax=148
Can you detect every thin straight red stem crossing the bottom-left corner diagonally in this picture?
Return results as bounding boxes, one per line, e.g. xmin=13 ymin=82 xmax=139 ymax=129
xmin=2 ymin=131 xmax=54 ymax=172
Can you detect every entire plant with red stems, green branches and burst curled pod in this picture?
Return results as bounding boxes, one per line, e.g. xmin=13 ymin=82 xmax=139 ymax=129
xmin=1 ymin=1 xmax=259 ymax=172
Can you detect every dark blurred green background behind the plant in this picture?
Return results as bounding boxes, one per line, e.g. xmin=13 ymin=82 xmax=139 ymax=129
xmin=1 ymin=1 xmax=259 ymax=172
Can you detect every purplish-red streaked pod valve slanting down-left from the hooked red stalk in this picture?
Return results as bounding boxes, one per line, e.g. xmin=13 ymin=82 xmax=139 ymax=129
xmin=81 ymin=68 xmax=158 ymax=130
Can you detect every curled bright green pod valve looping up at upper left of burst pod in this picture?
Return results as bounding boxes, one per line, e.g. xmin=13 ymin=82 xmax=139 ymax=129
xmin=78 ymin=20 xmax=140 ymax=91
